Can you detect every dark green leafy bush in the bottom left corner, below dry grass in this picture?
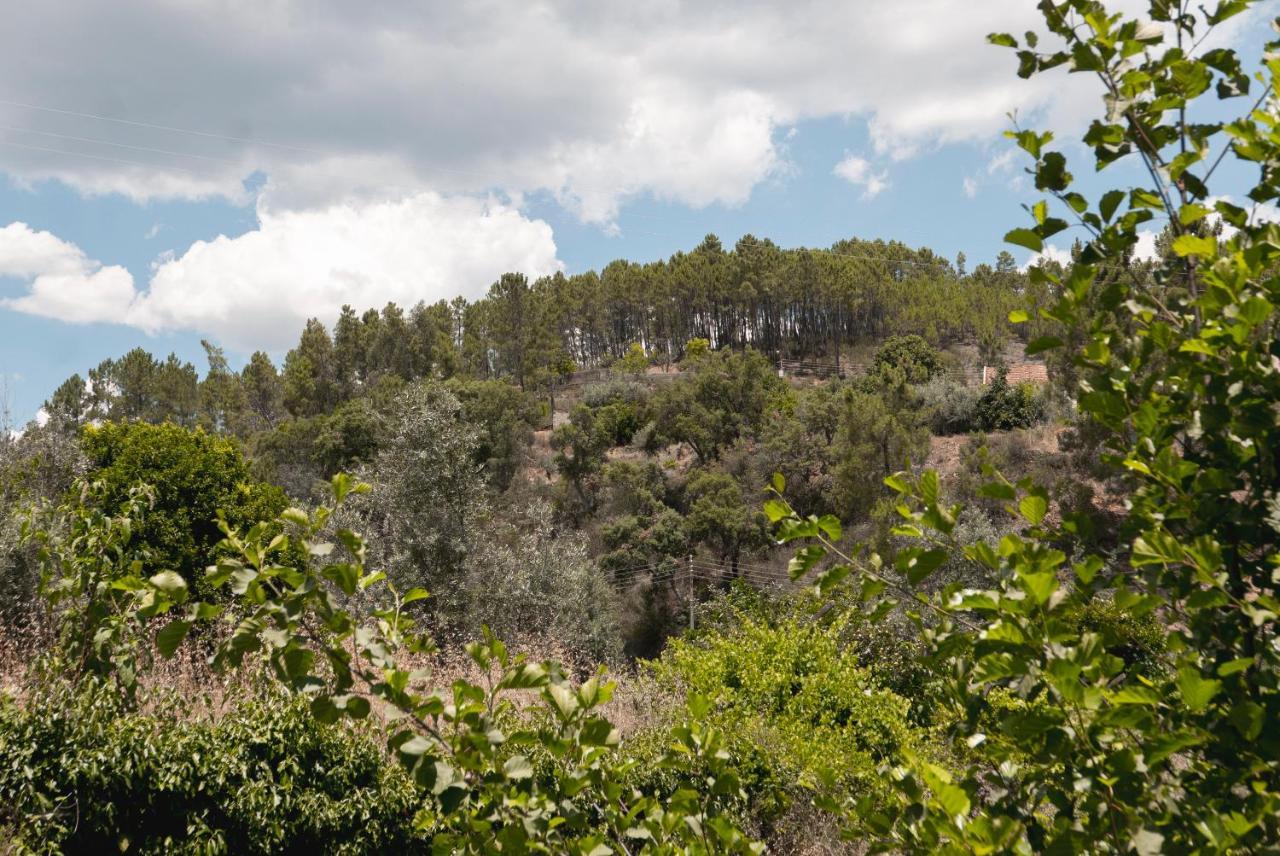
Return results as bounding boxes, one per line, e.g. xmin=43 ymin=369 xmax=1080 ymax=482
xmin=0 ymin=681 xmax=425 ymax=853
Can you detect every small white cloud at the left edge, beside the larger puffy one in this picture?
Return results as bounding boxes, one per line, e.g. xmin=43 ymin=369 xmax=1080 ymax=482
xmin=0 ymin=223 xmax=136 ymax=324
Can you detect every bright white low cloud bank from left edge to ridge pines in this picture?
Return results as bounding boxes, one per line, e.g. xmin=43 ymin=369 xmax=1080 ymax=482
xmin=0 ymin=193 xmax=561 ymax=351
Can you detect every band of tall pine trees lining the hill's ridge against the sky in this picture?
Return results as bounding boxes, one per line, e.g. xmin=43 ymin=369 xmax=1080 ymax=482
xmin=46 ymin=235 xmax=1027 ymax=436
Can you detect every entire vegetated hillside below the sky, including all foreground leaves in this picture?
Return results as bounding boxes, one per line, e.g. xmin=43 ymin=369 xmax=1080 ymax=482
xmin=0 ymin=0 xmax=1280 ymax=855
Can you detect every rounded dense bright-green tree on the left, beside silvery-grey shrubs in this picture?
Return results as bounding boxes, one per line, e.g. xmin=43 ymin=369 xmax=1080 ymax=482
xmin=80 ymin=422 xmax=287 ymax=596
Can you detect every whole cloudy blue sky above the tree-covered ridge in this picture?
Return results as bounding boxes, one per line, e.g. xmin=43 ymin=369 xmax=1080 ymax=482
xmin=0 ymin=0 xmax=1275 ymax=425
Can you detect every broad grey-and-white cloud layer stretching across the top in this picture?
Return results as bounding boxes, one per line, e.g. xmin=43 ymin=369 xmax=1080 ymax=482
xmin=0 ymin=0 xmax=1228 ymax=223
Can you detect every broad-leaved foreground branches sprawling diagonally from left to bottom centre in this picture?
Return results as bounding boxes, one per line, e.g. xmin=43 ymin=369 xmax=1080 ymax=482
xmin=42 ymin=476 xmax=759 ymax=853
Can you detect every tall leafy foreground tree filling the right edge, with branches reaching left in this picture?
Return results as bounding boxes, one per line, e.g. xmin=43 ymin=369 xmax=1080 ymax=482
xmin=769 ymin=0 xmax=1280 ymax=853
